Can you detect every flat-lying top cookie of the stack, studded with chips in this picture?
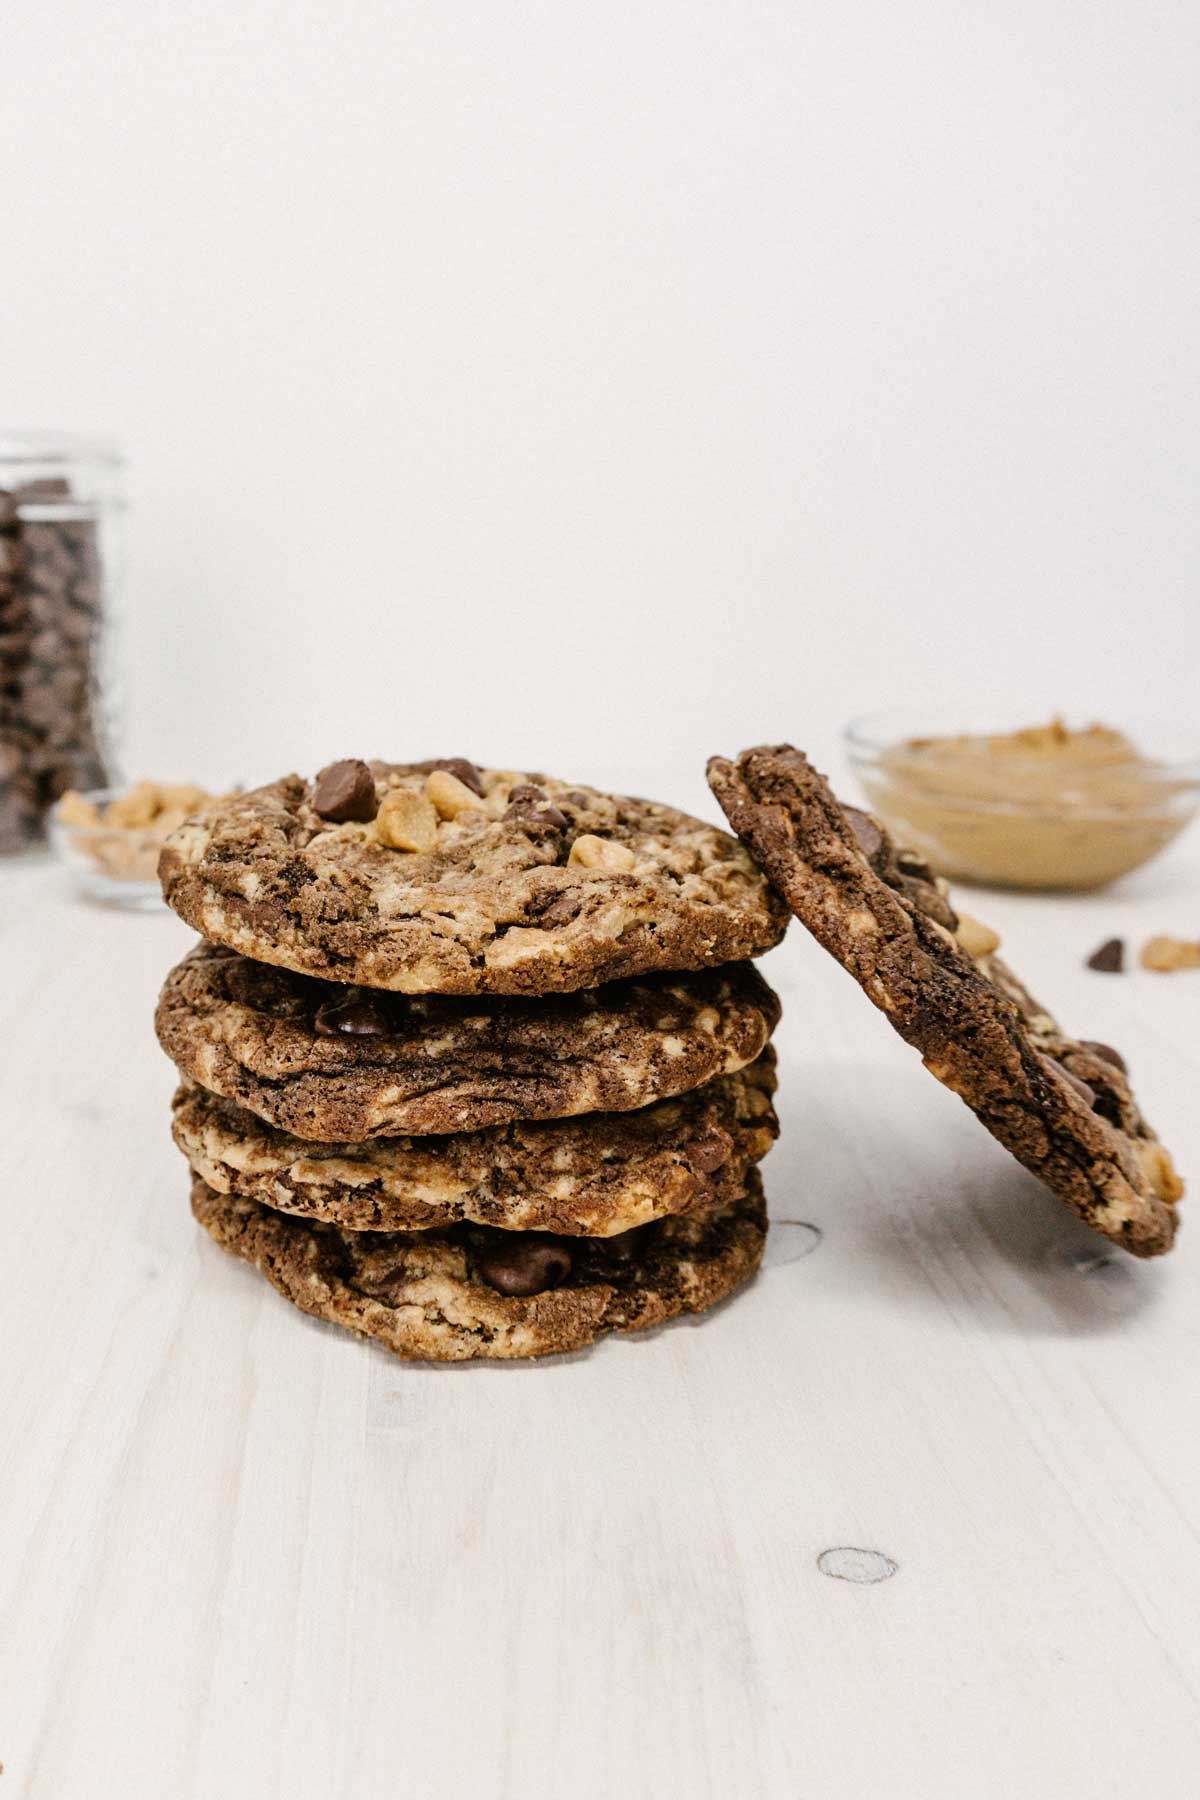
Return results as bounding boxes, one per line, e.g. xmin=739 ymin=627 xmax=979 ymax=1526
xmin=158 ymin=758 xmax=786 ymax=994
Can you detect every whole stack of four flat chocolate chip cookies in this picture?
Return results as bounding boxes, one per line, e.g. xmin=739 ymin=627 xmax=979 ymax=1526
xmin=157 ymin=758 xmax=786 ymax=1361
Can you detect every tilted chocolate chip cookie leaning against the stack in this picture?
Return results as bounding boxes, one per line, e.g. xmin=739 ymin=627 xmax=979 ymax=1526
xmin=709 ymin=743 xmax=1184 ymax=1256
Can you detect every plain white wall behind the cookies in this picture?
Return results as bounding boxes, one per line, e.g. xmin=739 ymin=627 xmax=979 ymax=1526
xmin=0 ymin=0 xmax=1200 ymax=797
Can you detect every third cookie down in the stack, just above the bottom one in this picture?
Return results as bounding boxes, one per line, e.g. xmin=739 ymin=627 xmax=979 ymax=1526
xmin=173 ymin=1049 xmax=779 ymax=1237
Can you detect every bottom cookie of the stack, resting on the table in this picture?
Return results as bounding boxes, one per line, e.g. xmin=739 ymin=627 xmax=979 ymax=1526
xmin=193 ymin=1170 xmax=766 ymax=1363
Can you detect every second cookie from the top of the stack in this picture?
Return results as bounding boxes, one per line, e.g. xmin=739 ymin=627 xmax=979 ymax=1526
xmin=155 ymin=943 xmax=779 ymax=1143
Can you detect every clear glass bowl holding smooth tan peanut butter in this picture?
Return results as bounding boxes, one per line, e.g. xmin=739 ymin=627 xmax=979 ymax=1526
xmin=846 ymin=709 xmax=1200 ymax=891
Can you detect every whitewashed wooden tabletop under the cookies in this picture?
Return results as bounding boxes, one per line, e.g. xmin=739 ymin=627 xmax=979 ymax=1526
xmin=0 ymin=846 xmax=1200 ymax=1800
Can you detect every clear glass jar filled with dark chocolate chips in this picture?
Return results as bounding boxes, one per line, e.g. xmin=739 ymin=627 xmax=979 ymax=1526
xmin=0 ymin=432 xmax=124 ymax=851
